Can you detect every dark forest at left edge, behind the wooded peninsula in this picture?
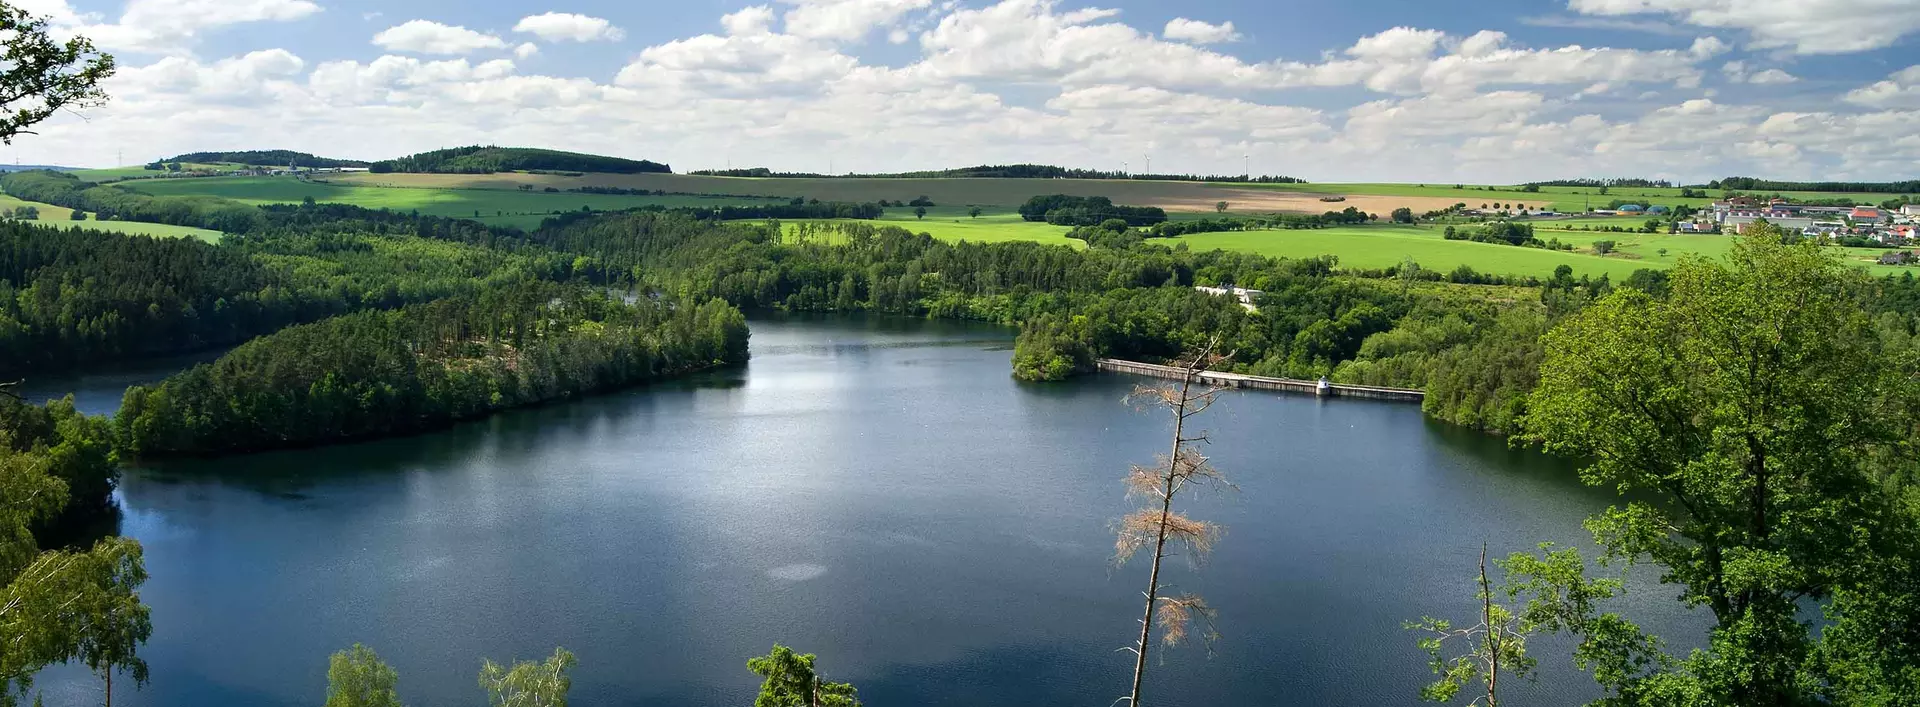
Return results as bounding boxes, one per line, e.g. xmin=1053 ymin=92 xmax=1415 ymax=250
xmin=0 ymin=207 xmax=572 ymax=377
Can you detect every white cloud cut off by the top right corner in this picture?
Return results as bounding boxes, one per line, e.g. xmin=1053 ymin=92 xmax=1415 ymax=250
xmin=1567 ymin=0 xmax=1920 ymax=54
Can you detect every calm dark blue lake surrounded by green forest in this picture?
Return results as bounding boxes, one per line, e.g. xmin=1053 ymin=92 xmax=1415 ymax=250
xmin=40 ymin=319 xmax=1697 ymax=707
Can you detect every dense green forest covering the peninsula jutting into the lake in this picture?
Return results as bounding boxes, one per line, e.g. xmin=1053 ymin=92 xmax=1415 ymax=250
xmin=115 ymin=280 xmax=747 ymax=455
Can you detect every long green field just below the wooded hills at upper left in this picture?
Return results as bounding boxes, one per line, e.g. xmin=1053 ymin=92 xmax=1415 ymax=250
xmin=125 ymin=177 xmax=783 ymax=227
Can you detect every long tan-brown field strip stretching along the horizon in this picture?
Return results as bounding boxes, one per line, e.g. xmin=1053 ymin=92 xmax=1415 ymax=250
xmin=326 ymin=173 xmax=1457 ymax=217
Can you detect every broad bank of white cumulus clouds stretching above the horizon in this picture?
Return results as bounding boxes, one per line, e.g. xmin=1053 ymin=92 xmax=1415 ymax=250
xmin=15 ymin=0 xmax=1920 ymax=183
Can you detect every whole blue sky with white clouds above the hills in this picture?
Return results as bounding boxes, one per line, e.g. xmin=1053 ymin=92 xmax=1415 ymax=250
xmin=0 ymin=0 xmax=1920 ymax=183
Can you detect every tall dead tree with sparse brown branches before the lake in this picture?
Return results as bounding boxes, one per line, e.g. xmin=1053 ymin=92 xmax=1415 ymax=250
xmin=1114 ymin=338 xmax=1231 ymax=707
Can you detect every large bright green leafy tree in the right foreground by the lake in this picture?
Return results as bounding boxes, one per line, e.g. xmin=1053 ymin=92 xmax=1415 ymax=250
xmin=1523 ymin=229 xmax=1920 ymax=705
